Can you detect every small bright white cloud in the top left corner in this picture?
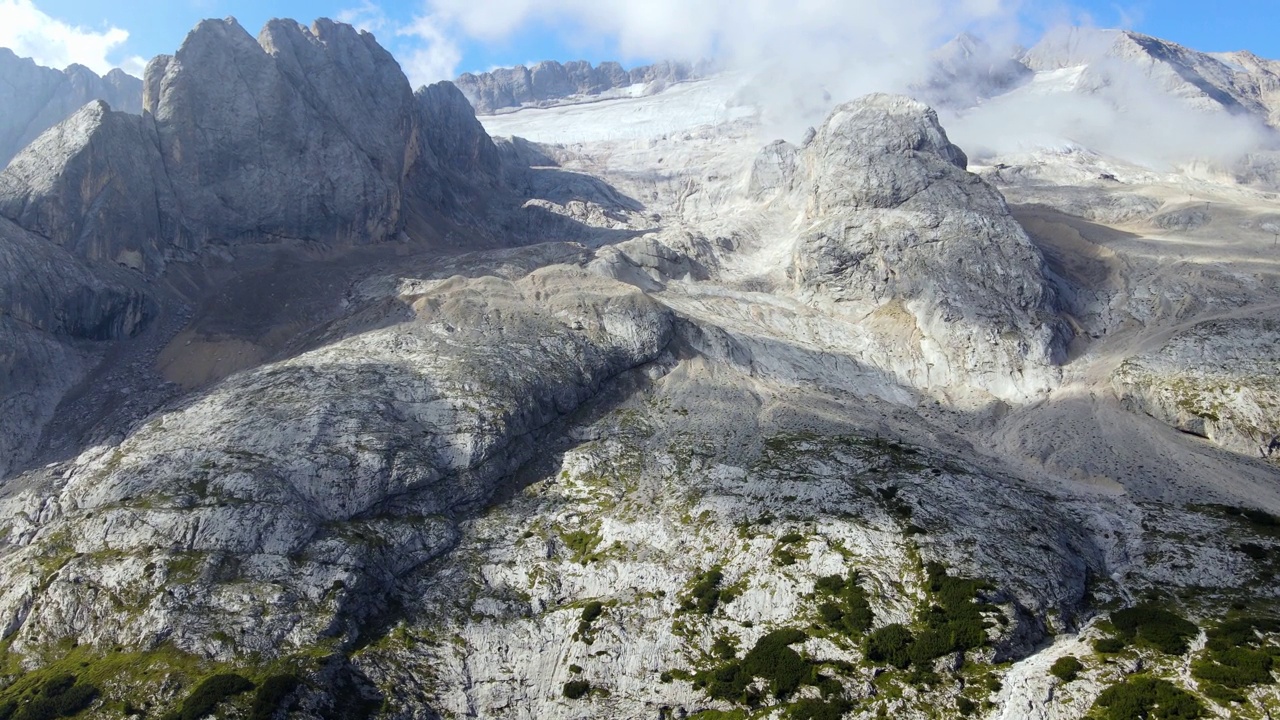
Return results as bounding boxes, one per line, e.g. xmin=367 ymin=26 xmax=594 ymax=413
xmin=0 ymin=0 xmax=146 ymax=74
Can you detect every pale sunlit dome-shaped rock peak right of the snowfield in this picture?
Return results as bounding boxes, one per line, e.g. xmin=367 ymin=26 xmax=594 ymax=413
xmin=751 ymin=95 xmax=1070 ymax=398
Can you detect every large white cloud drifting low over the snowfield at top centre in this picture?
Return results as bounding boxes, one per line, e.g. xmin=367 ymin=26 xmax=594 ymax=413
xmin=412 ymin=0 xmax=1020 ymax=136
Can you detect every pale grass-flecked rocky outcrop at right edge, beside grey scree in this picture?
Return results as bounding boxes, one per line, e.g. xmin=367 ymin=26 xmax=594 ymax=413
xmin=1112 ymin=318 xmax=1280 ymax=461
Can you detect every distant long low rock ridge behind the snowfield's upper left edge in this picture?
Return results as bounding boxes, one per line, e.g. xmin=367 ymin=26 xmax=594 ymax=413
xmin=454 ymin=60 xmax=700 ymax=114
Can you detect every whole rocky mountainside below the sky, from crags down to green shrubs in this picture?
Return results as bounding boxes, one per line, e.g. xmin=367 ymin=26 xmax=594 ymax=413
xmin=0 ymin=19 xmax=1280 ymax=720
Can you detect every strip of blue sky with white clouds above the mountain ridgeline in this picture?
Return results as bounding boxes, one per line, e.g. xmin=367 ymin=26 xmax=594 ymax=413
xmin=0 ymin=0 xmax=1280 ymax=86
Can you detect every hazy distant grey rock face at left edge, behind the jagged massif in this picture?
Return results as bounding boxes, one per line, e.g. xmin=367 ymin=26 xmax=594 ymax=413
xmin=0 ymin=47 xmax=142 ymax=168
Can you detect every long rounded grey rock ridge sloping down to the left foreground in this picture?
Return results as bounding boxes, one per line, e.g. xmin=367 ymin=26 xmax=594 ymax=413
xmin=0 ymin=269 xmax=672 ymax=657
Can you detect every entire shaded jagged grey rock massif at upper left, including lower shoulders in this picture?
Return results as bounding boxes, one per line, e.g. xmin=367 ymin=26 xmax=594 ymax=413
xmin=0 ymin=19 xmax=509 ymax=274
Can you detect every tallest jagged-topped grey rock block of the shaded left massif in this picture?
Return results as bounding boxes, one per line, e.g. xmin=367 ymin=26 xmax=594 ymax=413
xmin=143 ymin=20 xmax=413 ymax=246
